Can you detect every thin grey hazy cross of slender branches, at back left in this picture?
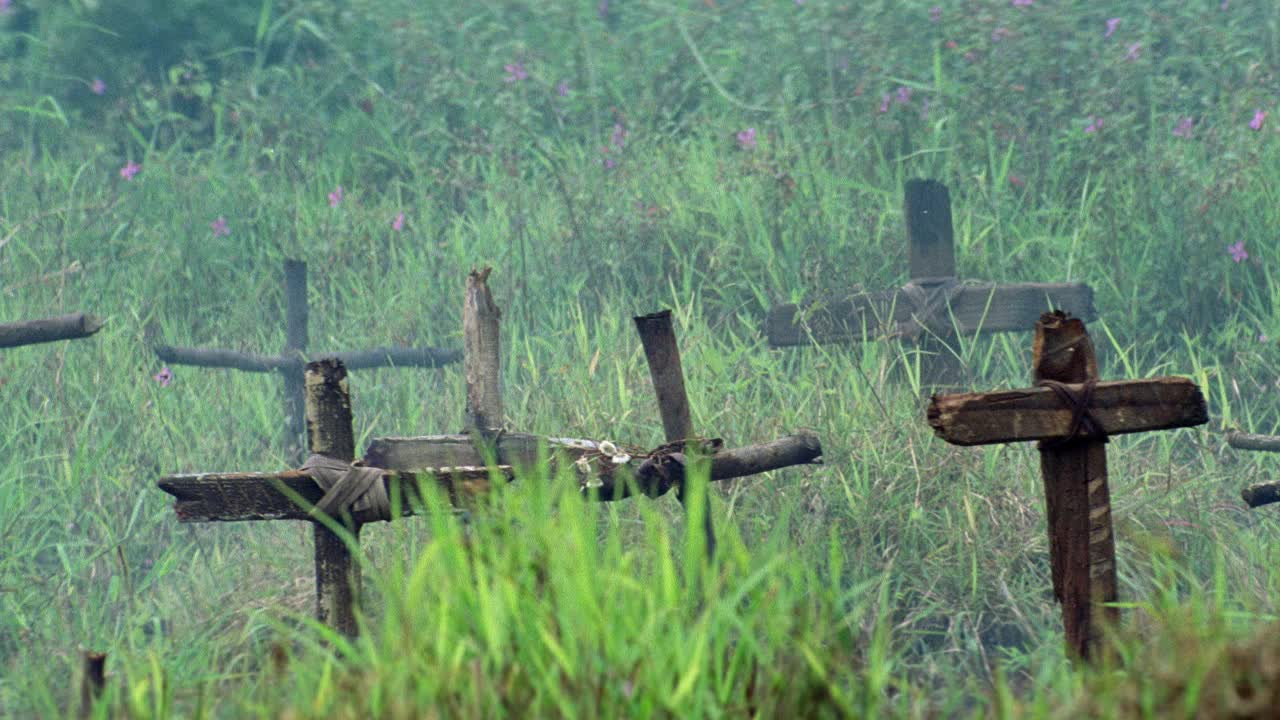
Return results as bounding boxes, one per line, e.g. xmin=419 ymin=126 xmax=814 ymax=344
xmin=155 ymin=254 xmax=462 ymax=446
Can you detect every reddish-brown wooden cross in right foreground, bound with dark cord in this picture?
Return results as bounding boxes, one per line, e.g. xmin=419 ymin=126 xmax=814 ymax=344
xmin=928 ymin=311 xmax=1208 ymax=660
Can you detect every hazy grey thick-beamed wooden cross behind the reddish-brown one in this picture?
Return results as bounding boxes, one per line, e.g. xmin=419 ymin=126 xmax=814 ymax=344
xmin=767 ymin=179 xmax=1096 ymax=387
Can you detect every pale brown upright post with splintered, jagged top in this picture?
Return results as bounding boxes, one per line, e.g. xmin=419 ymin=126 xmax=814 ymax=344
xmin=462 ymin=268 xmax=503 ymax=427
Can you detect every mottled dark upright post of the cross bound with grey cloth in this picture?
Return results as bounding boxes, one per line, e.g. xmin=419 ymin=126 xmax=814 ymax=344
xmin=305 ymin=359 xmax=361 ymax=637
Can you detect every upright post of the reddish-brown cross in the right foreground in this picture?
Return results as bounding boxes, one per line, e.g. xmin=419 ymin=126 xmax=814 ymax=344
xmin=1033 ymin=313 xmax=1119 ymax=660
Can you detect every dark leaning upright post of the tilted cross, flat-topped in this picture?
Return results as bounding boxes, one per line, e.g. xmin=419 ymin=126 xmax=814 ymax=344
xmin=635 ymin=310 xmax=716 ymax=557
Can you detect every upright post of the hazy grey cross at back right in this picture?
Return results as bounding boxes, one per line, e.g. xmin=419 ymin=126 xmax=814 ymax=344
xmin=902 ymin=179 xmax=964 ymax=395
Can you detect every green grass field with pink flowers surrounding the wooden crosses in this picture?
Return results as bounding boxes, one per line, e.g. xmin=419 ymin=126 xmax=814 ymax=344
xmin=0 ymin=0 xmax=1280 ymax=717
